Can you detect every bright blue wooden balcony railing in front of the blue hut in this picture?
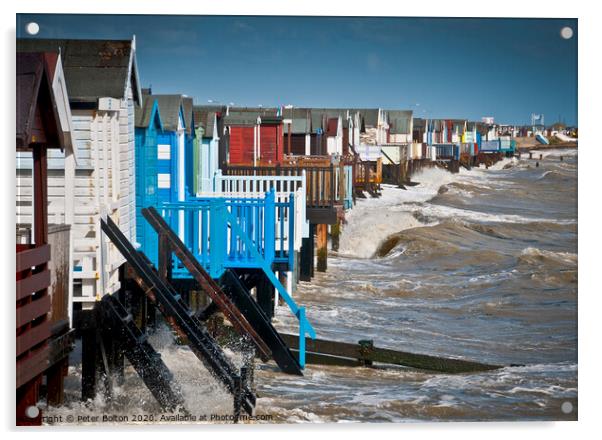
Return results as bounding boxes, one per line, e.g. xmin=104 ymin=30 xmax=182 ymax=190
xmin=154 ymin=190 xmax=295 ymax=278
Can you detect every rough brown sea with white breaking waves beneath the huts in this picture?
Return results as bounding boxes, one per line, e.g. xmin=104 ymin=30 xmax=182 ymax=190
xmin=42 ymin=149 xmax=578 ymax=425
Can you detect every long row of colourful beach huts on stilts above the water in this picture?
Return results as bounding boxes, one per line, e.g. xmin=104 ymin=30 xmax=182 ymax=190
xmin=16 ymin=38 xmax=515 ymax=425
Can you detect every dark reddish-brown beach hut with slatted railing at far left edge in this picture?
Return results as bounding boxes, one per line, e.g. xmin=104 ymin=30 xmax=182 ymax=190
xmin=15 ymin=53 xmax=75 ymax=425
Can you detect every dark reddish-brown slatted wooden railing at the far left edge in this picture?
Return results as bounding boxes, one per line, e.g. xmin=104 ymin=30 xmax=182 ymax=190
xmin=16 ymin=244 xmax=50 ymax=388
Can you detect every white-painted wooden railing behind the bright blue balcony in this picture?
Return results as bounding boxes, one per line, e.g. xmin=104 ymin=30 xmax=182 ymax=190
xmin=198 ymin=169 xmax=309 ymax=251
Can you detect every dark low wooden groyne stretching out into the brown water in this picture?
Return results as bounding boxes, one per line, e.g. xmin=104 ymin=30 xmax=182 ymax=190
xmin=280 ymin=333 xmax=502 ymax=373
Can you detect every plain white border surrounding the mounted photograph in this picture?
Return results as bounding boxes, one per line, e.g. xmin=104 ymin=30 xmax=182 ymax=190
xmin=0 ymin=0 xmax=602 ymax=440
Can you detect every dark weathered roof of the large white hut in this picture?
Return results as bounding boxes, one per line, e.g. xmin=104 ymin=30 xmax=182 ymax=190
xmin=17 ymin=38 xmax=140 ymax=102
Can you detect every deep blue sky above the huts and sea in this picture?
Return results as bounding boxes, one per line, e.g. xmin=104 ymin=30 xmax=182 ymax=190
xmin=17 ymin=14 xmax=578 ymax=124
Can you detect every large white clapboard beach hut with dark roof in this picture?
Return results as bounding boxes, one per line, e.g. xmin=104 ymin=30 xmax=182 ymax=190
xmin=17 ymin=39 xmax=142 ymax=309
